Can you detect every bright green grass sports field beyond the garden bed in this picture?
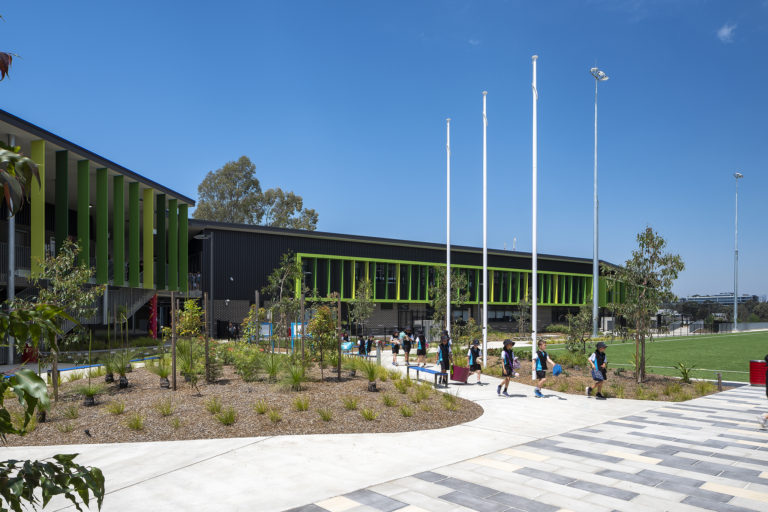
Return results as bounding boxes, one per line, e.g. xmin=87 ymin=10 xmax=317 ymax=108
xmin=547 ymin=332 xmax=768 ymax=382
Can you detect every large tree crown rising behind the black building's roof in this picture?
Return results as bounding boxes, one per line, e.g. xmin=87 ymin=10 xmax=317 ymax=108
xmin=194 ymin=156 xmax=318 ymax=231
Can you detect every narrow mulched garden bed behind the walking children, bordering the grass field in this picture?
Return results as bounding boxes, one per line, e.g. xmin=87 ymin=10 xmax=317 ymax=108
xmin=485 ymin=355 xmax=731 ymax=402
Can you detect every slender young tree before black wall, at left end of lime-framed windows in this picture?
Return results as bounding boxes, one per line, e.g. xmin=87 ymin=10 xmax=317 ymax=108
xmin=263 ymin=251 xmax=302 ymax=352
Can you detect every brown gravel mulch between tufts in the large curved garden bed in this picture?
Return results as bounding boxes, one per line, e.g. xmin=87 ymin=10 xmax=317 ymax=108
xmin=6 ymin=366 xmax=482 ymax=446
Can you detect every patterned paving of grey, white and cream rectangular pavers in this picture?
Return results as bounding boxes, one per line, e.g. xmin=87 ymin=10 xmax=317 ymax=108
xmin=291 ymin=387 xmax=768 ymax=512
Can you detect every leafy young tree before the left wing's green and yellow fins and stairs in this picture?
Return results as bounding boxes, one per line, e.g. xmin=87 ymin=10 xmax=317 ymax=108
xmin=26 ymin=240 xmax=104 ymax=401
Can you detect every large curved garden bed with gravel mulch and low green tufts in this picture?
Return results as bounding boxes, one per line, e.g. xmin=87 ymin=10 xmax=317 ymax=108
xmin=6 ymin=343 xmax=482 ymax=445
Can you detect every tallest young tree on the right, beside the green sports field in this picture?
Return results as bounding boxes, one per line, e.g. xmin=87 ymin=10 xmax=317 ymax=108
xmin=612 ymin=227 xmax=685 ymax=383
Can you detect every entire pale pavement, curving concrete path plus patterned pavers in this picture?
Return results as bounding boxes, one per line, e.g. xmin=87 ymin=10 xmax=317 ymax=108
xmin=3 ymin=370 xmax=768 ymax=512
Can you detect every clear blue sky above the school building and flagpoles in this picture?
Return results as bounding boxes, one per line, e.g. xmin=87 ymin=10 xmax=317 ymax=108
xmin=0 ymin=0 xmax=768 ymax=295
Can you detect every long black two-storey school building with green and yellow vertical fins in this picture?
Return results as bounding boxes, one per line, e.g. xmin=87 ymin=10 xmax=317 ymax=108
xmin=0 ymin=110 xmax=611 ymax=364
